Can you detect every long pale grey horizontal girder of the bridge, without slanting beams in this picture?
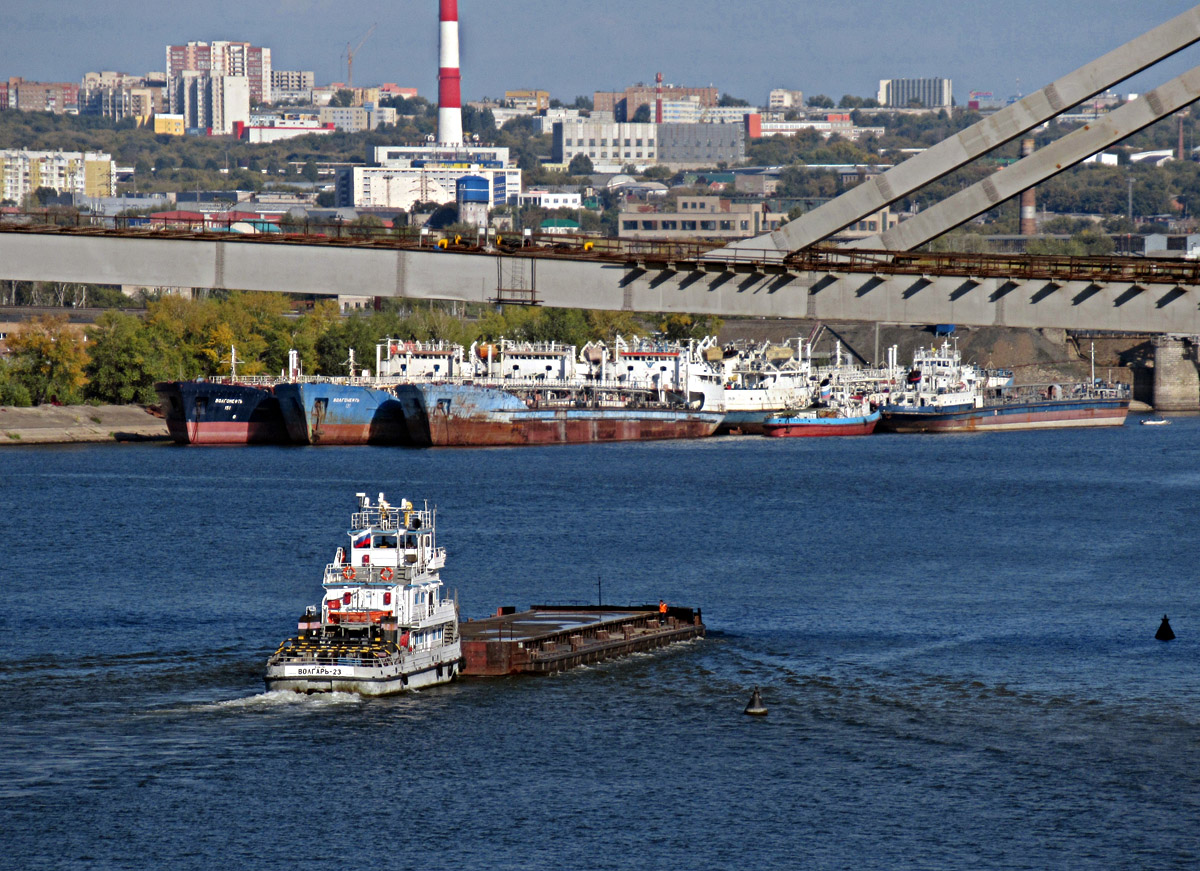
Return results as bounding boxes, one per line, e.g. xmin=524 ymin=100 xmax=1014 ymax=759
xmin=7 ymin=233 xmax=1200 ymax=335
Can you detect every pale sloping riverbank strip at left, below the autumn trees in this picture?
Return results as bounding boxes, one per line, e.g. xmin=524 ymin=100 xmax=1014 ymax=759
xmin=0 ymin=406 xmax=170 ymax=445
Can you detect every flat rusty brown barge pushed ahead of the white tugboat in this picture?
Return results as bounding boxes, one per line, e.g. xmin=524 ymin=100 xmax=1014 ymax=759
xmin=458 ymin=605 xmax=704 ymax=677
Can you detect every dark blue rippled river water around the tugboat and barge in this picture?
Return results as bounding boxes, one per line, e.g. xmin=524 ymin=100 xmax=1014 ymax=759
xmin=0 ymin=419 xmax=1200 ymax=870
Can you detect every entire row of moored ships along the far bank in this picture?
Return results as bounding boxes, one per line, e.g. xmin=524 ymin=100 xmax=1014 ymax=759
xmin=156 ymin=337 xmax=1129 ymax=446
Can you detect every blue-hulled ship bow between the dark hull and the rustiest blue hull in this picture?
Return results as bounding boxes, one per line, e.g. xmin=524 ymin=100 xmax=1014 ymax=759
xmin=275 ymin=382 xmax=412 ymax=445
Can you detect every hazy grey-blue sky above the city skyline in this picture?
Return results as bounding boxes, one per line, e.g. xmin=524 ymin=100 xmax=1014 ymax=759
xmin=0 ymin=0 xmax=1200 ymax=104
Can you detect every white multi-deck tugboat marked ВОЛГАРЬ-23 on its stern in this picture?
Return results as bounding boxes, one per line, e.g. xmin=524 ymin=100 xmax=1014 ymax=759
xmin=265 ymin=493 xmax=462 ymax=696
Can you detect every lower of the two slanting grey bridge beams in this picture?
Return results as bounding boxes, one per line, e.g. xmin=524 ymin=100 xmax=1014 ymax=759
xmin=845 ymin=66 xmax=1200 ymax=251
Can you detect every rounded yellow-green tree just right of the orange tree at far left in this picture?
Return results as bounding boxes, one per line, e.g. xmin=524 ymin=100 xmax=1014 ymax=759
xmin=84 ymin=312 xmax=167 ymax=404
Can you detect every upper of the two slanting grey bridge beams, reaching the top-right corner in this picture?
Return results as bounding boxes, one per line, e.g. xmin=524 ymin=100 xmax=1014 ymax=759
xmin=709 ymin=6 xmax=1200 ymax=259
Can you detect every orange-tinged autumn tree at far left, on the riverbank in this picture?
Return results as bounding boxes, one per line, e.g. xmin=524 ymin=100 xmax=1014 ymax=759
xmin=8 ymin=314 xmax=88 ymax=406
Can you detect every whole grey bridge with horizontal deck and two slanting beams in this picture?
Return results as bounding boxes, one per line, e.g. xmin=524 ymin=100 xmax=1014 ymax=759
xmin=0 ymin=6 xmax=1200 ymax=405
